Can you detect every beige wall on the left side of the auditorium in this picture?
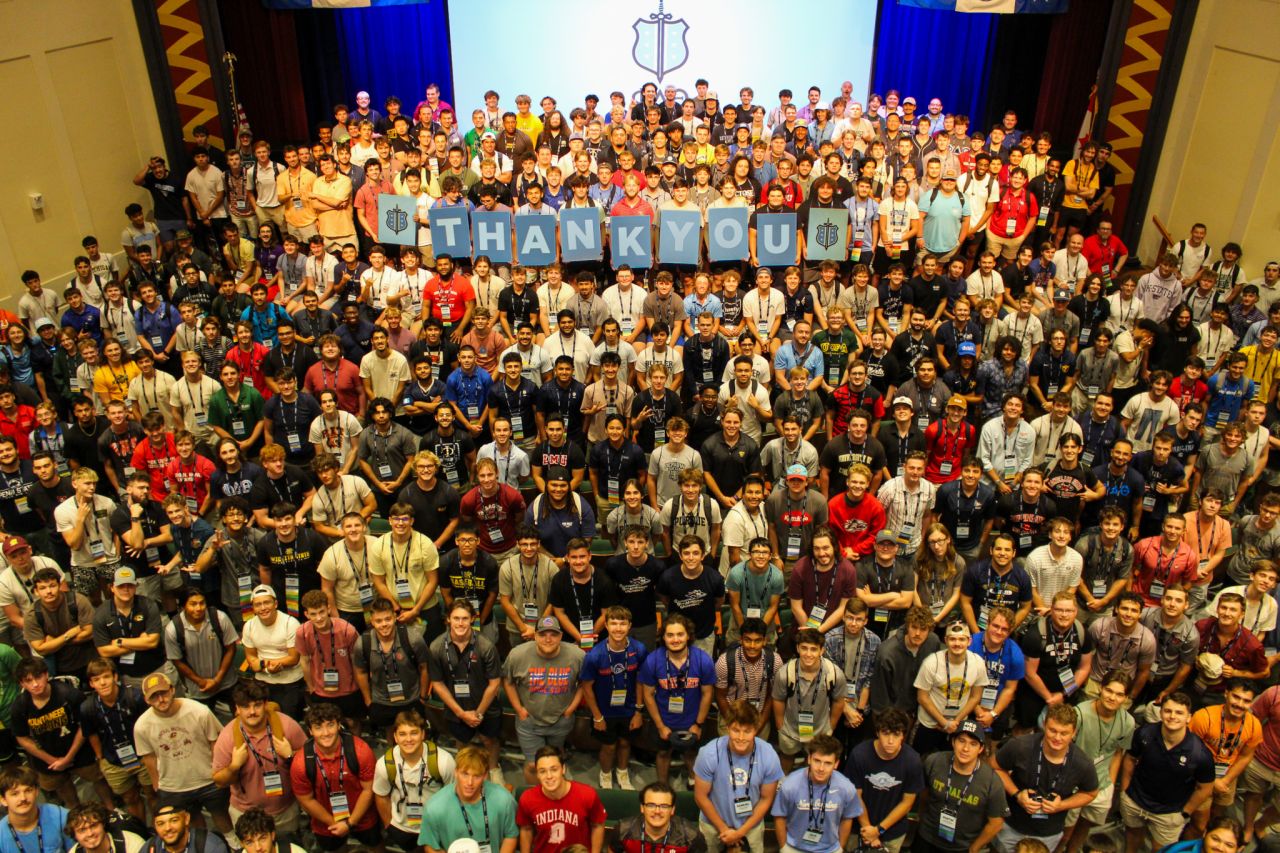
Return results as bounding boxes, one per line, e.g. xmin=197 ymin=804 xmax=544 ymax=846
xmin=0 ymin=0 xmax=164 ymax=302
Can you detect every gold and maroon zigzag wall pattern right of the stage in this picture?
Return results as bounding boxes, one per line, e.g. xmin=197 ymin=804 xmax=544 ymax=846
xmin=1102 ymin=0 xmax=1174 ymax=229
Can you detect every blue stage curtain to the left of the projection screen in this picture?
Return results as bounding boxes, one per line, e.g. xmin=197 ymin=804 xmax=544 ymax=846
xmin=330 ymin=0 xmax=455 ymax=116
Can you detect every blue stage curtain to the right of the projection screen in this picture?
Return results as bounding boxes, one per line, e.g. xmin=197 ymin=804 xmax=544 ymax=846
xmin=872 ymin=0 xmax=997 ymax=129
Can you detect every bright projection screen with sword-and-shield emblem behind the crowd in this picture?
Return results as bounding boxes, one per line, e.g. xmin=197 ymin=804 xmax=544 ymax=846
xmin=449 ymin=0 xmax=876 ymax=117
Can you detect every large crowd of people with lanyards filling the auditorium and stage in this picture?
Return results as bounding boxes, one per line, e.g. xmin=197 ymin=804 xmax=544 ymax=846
xmin=0 ymin=74 xmax=1280 ymax=853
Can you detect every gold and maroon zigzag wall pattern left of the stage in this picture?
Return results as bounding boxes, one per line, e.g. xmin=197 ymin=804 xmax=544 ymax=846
xmin=156 ymin=0 xmax=227 ymax=149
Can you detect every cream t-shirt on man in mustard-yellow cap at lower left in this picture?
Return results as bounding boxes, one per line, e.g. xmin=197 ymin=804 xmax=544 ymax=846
xmin=133 ymin=699 xmax=221 ymax=793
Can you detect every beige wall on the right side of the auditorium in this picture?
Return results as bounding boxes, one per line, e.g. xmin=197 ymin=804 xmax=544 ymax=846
xmin=1139 ymin=0 xmax=1280 ymax=268
